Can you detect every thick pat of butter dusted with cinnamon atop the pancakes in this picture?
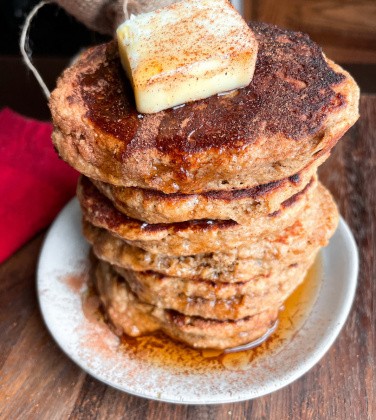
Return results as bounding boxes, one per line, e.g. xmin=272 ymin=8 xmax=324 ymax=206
xmin=117 ymin=0 xmax=257 ymax=113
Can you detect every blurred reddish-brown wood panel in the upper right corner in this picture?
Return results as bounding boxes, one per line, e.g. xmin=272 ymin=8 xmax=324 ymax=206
xmin=244 ymin=0 xmax=376 ymax=63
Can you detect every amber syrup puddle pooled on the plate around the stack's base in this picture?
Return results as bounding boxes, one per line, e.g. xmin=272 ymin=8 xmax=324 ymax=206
xmin=83 ymin=255 xmax=322 ymax=372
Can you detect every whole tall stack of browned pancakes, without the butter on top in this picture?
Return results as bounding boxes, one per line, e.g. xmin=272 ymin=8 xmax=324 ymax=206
xmin=50 ymin=23 xmax=359 ymax=349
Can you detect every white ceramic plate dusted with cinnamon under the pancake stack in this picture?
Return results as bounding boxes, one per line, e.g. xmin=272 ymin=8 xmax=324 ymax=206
xmin=37 ymin=199 xmax=358 ymax=404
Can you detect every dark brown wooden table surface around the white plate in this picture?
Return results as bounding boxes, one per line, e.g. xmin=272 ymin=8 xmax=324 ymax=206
xmin=0 ymin=66 xmax=376 ymax=420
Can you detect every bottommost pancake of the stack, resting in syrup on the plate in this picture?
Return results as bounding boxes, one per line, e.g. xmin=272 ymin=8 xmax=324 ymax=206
xmin=94 ymin=264 xmax=279 ymax=349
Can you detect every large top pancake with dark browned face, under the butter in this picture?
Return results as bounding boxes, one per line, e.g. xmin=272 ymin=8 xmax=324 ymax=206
xmin=50 ymin=23 xmax=359 ymax=193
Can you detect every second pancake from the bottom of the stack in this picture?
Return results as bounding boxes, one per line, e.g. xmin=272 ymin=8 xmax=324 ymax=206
xmin=111 ymin=255 xmax=315 ymax=320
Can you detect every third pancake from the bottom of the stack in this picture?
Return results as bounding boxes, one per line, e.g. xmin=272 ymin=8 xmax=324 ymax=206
xmin=83 ymin=179 xmax=338 ymax=283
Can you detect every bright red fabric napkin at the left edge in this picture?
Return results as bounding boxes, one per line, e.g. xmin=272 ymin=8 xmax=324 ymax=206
xmin=0 ymin=108 xmax=78 ymax=262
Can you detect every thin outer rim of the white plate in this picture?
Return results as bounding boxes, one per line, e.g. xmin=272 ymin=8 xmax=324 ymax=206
xmin=36 ymin=197 xmax=359 ymax=405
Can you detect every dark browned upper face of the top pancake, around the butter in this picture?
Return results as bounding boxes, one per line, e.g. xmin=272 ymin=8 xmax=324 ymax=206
xmin=78 ymin=22 xmax=345 ymax=153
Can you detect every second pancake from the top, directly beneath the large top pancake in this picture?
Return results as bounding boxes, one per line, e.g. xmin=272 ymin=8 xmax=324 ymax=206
xmin=92 ymin=155 xmax=327 ymax=225
